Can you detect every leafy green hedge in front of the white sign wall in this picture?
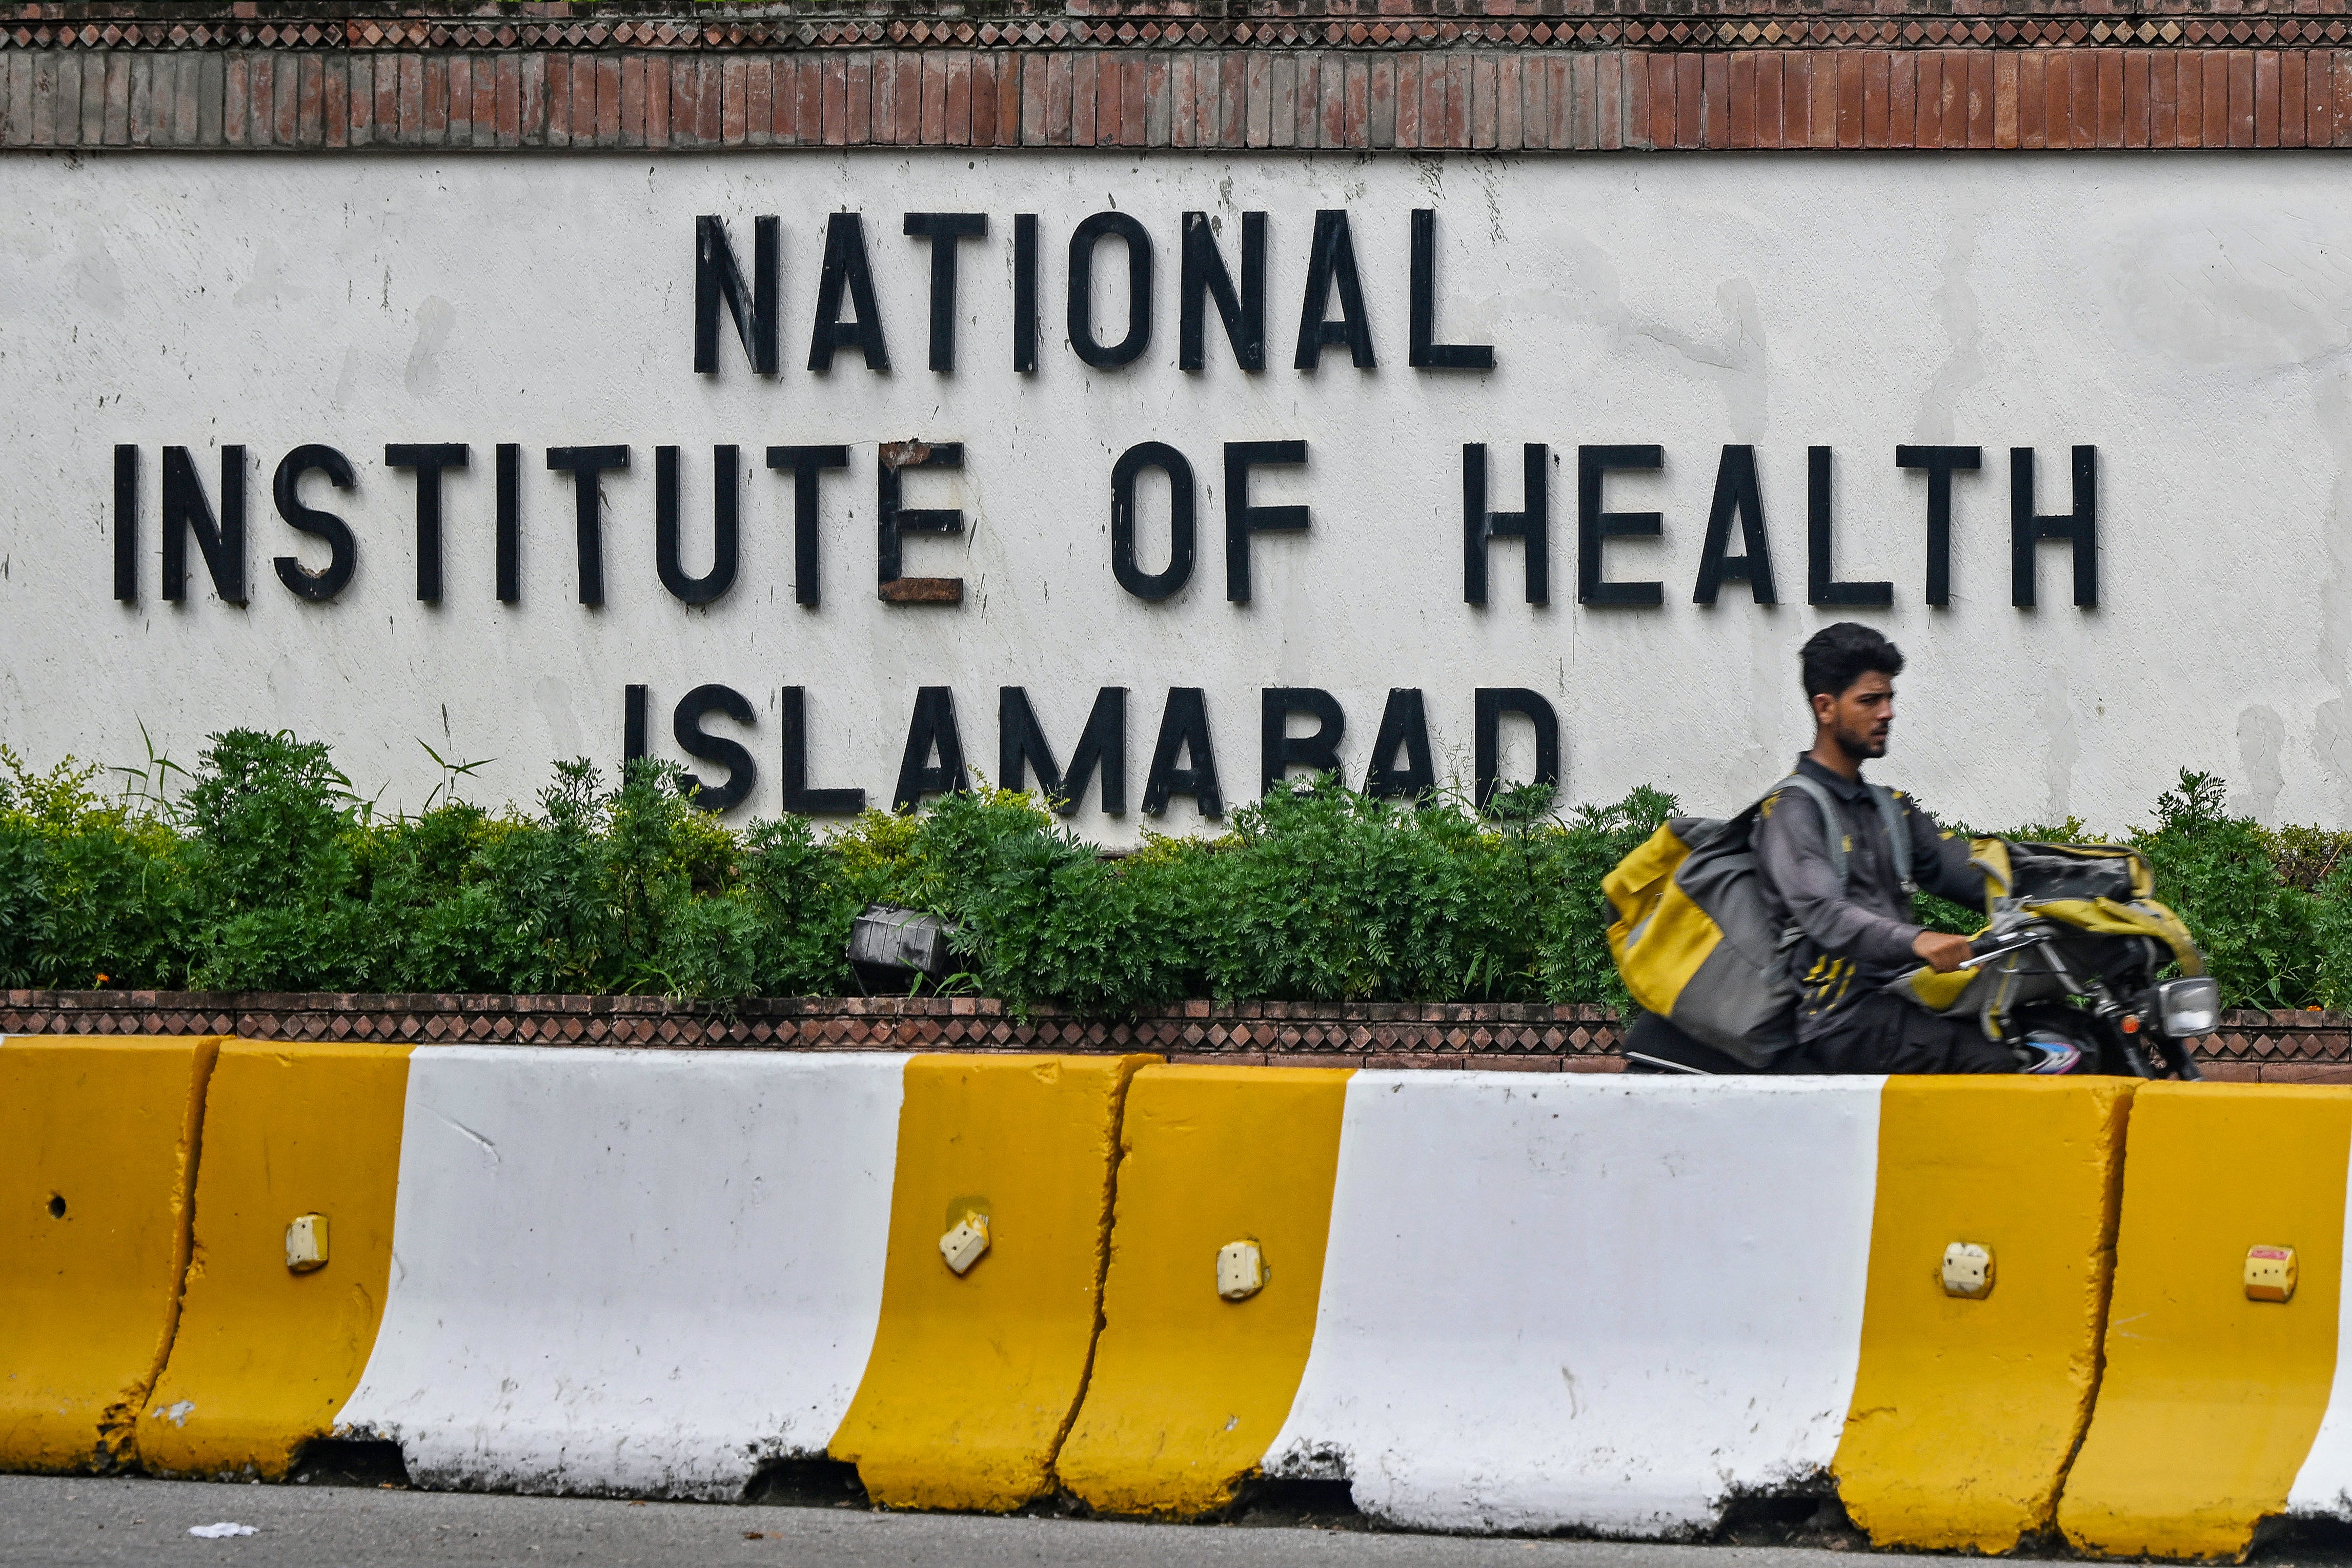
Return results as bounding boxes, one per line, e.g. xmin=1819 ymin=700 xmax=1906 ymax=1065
xmin=0 ymin=731 xmax=2352 ymax=1013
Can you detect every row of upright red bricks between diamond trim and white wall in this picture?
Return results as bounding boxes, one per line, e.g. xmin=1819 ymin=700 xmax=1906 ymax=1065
xmin=0 ymin=39 xmax=2352 ymax=155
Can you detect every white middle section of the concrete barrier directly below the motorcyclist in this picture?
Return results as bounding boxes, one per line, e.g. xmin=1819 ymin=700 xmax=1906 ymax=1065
xmin=1265 ymin=1072 xmax=1884 ymax=1537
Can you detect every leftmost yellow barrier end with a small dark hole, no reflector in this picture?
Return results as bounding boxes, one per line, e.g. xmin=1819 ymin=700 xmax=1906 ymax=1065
xmin=0 ymin=1034 xmax=219 ymax=1469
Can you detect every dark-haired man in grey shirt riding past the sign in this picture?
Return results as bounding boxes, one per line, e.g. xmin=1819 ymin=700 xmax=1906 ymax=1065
xmin=1752 ymin=621 xmax=2079 ymax=1072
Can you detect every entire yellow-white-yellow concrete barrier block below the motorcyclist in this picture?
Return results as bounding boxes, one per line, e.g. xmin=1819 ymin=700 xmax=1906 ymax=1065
xmin=1056 ymin=1067 xmax=2131 ymax=1552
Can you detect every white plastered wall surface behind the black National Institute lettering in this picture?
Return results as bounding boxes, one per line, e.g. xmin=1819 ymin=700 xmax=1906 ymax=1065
xmin=0 ymin=153 xmax=2352 ymax=839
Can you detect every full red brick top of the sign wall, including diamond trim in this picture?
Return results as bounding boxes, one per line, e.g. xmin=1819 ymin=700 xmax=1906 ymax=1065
xmin=0 ymin=0 xmax=2352 ymax=151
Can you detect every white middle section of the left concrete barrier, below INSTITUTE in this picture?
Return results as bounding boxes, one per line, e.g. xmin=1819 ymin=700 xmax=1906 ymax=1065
xmin=339 ymin=1046 xmax=905 ymax=1497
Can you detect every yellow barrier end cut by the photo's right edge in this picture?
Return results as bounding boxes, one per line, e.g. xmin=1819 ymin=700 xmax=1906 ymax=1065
xmin=2058 ymin=1084 xmax=2352 ymax=1559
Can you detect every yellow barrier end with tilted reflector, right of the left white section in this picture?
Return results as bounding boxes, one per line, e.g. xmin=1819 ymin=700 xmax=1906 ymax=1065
xmin=828 ymin=1055 xmax=1160 ymax=1512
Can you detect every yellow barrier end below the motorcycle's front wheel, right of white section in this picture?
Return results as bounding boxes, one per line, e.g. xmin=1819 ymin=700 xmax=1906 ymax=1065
xmin=1835 ymin=1076 xmax=2133 ymax=1552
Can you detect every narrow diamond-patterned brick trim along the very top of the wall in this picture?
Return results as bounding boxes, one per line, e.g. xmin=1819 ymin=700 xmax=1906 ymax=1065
xmin=0 ymin=0 xmax=2352 ymax=52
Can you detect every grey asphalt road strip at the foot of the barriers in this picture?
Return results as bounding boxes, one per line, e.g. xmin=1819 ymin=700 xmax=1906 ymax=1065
xmin=0 ymin=1476 xmax=1891 ymax=1568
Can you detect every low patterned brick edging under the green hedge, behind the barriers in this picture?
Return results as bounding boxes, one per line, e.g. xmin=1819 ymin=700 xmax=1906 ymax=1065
xmin=0 ymin=990 xmax=2352 ymax=1084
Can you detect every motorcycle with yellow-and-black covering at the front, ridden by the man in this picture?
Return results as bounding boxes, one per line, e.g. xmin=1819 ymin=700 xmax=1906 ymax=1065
xmin=1625 ymin=839 xmax=2220 ymax=1082
